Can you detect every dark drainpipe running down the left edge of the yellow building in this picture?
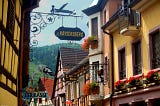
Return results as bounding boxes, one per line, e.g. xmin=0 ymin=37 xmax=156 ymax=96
xmin=103 ymin=29 xmax=114 ymax=106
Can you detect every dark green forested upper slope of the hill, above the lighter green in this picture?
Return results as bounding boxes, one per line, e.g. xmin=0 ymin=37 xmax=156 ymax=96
xmin=30 ymin=43 xmax=81 ymax=73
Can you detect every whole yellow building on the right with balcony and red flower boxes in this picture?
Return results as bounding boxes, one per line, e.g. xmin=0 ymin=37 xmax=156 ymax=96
xmin=102 ymin=0 xmax=160 ymax=106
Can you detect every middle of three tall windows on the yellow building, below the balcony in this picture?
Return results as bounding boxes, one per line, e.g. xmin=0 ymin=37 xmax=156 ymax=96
xmin=132 ymin=40 xmax=142 ymax=75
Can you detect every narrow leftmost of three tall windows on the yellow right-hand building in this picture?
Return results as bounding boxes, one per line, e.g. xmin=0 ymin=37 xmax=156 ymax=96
xmin=118 ymin=48 xmax=126 ymax=79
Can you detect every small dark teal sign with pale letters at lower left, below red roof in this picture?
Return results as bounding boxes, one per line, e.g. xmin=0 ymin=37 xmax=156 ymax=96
xmin=22 ymin=92 xmax=48 ymax=99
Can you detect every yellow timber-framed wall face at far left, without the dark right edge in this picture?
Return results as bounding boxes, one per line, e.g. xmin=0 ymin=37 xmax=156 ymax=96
xmin=0 ymin=0 xmax=21 ymax=106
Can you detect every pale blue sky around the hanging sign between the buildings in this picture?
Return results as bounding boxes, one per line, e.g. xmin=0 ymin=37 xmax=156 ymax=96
xmin=30 ymin=0 xmax=95 ymax=47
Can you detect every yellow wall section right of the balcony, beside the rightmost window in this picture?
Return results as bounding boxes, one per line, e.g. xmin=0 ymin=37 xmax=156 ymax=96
xmin=141 ymin=0 xmax=160 ymax=73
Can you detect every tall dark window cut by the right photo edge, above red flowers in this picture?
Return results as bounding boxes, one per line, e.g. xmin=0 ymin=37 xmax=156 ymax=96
xmin=150 ymin=30 xmax=160 ymax=69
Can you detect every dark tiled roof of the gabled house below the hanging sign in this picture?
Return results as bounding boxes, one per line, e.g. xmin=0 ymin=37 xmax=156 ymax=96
xmin=60 ymin=47 xmax=88 ymax=68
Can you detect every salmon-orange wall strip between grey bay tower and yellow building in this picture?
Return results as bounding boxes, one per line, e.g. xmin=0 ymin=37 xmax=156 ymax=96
xmin=102 ymin=0 xmax=121 ymax=97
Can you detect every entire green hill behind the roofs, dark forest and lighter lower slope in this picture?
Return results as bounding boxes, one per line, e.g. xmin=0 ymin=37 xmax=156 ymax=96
xmin=29 ymin=43 xmax=81 ymax=86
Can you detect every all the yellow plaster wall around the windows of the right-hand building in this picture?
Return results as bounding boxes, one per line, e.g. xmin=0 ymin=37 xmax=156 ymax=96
xmin=112 ymin=0 xmax=160 ymax=81
